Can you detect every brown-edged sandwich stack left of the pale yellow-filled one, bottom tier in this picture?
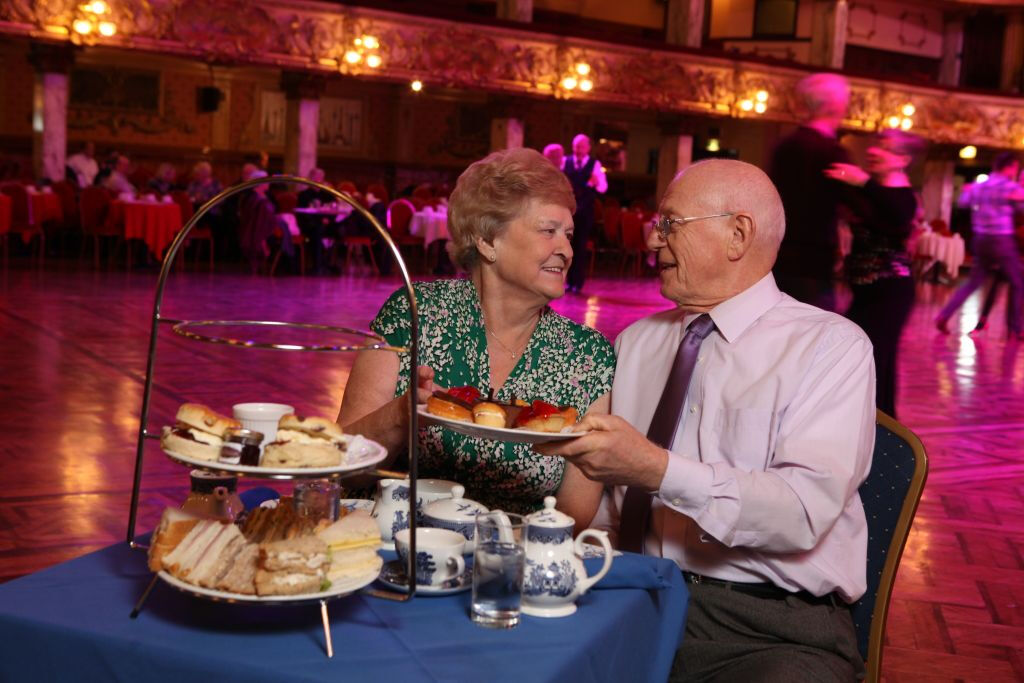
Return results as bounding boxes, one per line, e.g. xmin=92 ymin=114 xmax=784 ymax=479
xmin=255 ymin=536 xmax=328 ymax=595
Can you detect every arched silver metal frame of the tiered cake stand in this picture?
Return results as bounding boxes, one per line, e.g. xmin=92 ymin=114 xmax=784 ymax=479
xmin=127 ymin=175 xmax=419 ymax=656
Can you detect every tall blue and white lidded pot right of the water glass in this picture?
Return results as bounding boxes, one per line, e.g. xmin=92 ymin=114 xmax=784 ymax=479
xmin=522 ymin=496 xmax=611 ymax=616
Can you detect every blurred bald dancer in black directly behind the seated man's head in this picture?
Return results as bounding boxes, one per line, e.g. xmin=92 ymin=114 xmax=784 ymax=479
xmin=768 ymin=74 xmax=850 ymax=311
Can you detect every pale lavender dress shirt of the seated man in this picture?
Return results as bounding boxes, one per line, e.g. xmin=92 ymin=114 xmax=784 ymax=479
xmin=594 ymin=273 xmax=874 ymax=602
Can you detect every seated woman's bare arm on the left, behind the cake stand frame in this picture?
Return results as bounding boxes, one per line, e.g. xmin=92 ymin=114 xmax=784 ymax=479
xmin=338 ymin=351 xmax=434 ymax=467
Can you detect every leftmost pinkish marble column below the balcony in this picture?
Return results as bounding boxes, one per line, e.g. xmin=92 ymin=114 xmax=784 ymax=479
xmin=29 ymin=43 xmax=75 ymax=182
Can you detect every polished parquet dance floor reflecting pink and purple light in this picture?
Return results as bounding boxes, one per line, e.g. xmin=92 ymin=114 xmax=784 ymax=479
xmin=0 ymin=262 xmax=1024 ymax=683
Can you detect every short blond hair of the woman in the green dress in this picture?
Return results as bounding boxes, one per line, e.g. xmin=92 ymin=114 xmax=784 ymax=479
xmin=447 ymin=147 xmax=575 ymax=270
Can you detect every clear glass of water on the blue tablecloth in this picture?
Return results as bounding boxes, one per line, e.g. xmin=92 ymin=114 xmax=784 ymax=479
xmin=470 ymin=510 xmax=526 ymax=629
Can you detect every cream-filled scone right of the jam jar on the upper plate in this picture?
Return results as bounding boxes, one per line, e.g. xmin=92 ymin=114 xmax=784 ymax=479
xmin=260 ymin=415 xmax=348 ymax=467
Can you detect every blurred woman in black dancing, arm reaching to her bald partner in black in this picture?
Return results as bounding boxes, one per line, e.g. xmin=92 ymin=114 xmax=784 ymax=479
xmin=825 ymin=129 xmax=925 ymax=417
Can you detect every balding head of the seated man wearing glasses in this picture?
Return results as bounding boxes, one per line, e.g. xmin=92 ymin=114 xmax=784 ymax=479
xmin=648 ymin=159 xmax=785 ymax=312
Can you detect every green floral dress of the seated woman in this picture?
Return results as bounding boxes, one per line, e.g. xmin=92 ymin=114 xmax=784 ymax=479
xmin=372 ymin=280 xmax=615 ymax=513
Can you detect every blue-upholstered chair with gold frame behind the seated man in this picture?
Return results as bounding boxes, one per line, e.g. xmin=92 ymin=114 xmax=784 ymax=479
xmin=850 ymin=411 xmax=928 ymax=683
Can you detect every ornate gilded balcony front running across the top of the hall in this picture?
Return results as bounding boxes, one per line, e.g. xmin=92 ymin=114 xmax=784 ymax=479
xmin=0 ymin=0 xmax=1024 ymax=147
